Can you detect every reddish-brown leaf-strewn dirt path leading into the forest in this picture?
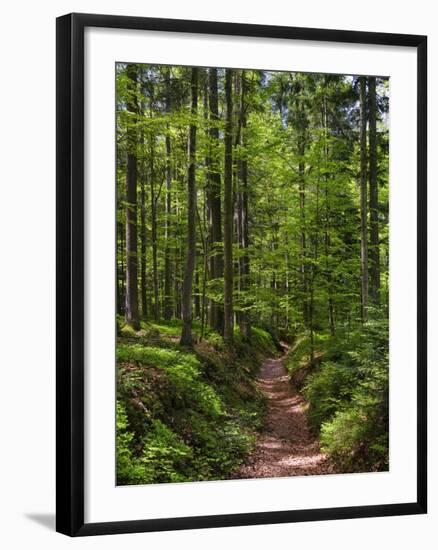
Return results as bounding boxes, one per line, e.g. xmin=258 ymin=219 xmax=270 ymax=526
xmin=236 ymin=357 xmax=333 ymax=478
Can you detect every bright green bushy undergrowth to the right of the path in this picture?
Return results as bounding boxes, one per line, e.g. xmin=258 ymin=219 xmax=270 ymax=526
xmin=295 ymin=318 xmax=389 ymax=472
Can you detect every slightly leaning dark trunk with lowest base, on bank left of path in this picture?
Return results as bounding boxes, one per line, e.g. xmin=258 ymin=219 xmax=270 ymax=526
xmin=180 ymin=67 xmax=198 ymax=346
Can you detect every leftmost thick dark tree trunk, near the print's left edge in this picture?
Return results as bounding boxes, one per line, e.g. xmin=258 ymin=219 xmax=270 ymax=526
xmin=125 ymin=65 xmax=140 ymax=330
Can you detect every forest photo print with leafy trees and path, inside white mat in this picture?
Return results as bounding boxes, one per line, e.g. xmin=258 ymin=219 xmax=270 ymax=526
xmin=115 ymin=62 xmax=390 ymax=485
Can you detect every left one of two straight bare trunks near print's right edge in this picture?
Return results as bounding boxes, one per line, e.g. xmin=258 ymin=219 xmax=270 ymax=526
xmin=359 ymin=76 xmax=368 ymax=322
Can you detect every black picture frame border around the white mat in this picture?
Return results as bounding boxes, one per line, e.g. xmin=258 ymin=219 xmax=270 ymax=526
xmin=56 ymin=13 xmax=427 ymax=536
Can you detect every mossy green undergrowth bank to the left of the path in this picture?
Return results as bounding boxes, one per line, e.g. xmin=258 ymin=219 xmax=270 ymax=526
xmin=117 ymin=325 xmax=274 ymax=485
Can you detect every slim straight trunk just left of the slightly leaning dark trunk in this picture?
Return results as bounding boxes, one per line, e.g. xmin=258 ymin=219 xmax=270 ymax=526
xmin=163 ymin=69 xmax=172 ymax=320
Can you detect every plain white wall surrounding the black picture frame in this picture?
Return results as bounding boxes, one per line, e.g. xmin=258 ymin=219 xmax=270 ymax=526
xmin=0 ymin=0 xmax=432 ymax=550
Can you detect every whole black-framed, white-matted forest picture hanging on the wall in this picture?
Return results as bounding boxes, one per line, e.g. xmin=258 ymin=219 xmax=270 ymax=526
xmin=57 ymin=14 xmax=427 ymax=536
